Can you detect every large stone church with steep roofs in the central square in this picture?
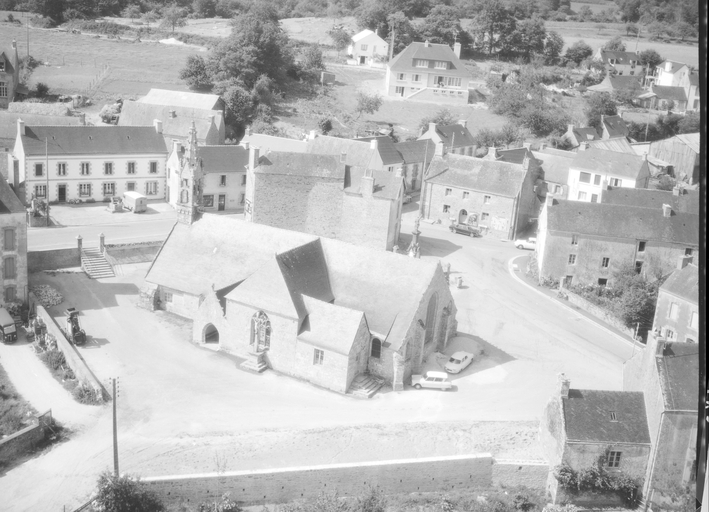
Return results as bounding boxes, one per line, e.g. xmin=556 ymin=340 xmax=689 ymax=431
xmin=140 ymin=212 xmax=456 ymax=393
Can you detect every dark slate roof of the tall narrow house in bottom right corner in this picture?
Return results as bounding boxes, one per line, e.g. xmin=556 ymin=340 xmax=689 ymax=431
xmin=655 ymin=343 xmax=699 ymax=411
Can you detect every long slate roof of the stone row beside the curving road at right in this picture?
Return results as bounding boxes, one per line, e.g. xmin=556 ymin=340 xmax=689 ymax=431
xmin=547 ymin=199 xmax=699 ymax=247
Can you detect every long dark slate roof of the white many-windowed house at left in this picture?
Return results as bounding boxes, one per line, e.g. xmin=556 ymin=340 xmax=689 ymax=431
xmin=22 ymin=126 xmax=167 ymax=155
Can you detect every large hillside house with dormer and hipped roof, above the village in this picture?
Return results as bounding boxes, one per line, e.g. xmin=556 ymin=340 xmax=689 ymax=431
xmin=385 ymin=41 xmax=473 ymax=105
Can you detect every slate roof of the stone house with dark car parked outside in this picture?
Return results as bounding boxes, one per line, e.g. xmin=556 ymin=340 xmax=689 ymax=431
xmin=426 ymin=153 xmax=526 ymax=197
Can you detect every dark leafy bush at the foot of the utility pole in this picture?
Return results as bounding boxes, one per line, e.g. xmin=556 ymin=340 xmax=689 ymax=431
xmin=94 ymin=472 xmax=165 ymax=512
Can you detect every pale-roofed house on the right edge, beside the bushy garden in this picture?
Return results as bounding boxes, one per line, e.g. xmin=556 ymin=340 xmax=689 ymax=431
xmin=653 ymin=256 xmax=699 ymax=343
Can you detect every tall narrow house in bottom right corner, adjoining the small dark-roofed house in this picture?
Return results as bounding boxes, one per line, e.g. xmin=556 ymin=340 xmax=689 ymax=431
xmin=623 ymin=332 xmax=705 ymax=510
